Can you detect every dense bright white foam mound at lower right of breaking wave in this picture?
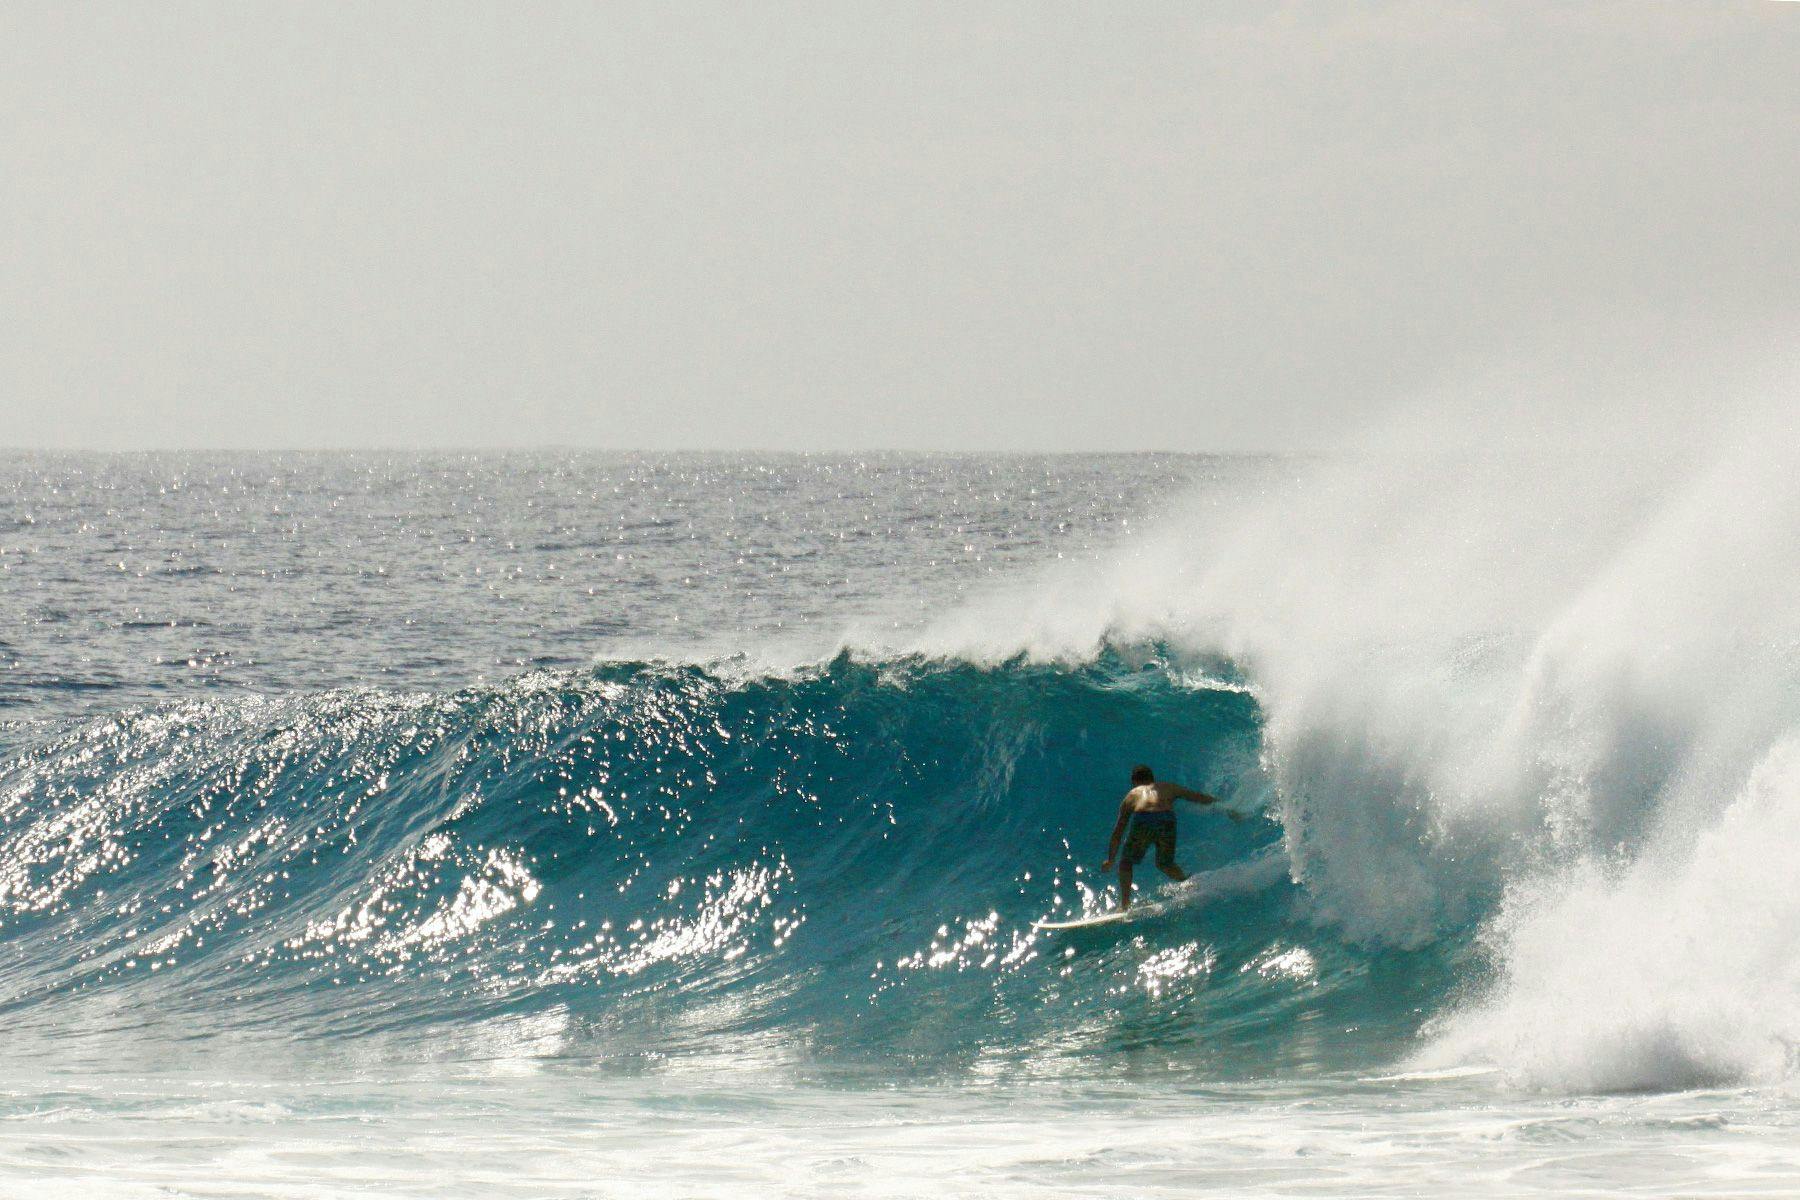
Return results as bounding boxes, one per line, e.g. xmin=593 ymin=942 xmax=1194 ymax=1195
xmin=1424 ymin=741 xmax=1800 ymax=1090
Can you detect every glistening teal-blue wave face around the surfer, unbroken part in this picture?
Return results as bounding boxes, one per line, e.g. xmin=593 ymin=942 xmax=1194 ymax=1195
xmin=0 ymin=651 xmax=1454 ymax=1074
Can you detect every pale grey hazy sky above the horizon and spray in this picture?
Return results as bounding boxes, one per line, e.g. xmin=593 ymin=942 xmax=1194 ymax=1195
xmin=0 ymin=0 xmax=1800 ymax=450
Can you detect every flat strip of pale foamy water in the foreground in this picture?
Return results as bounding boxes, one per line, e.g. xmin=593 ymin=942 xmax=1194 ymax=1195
xmin=0 ymin=1070 xmax=1800 ymax=1200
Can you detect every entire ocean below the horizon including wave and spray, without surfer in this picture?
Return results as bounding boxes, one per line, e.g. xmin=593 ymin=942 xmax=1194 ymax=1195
xmin=0 ymin=453 xmax=1800 ymax=1200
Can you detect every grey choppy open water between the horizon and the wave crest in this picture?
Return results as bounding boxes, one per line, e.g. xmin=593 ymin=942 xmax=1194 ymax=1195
xmin=0 ymin=453 xmax=1209 ymax=716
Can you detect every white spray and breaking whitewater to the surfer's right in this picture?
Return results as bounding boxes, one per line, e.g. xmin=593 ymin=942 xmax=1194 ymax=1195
xmin=922 ymin=390 xmax=1800 ymax=1090
